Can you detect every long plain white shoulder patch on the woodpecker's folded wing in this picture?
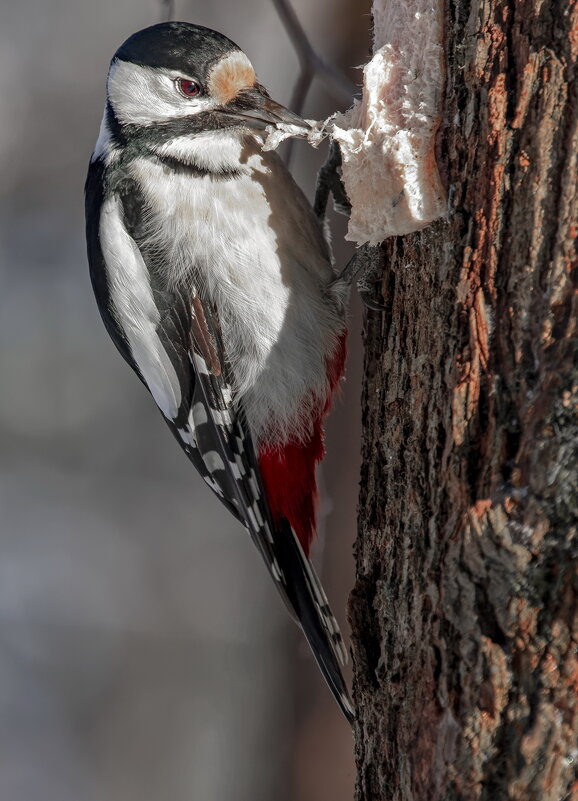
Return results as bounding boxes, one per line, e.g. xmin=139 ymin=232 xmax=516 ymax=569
xmin=100 ymin=196 xmax=181 ymax=420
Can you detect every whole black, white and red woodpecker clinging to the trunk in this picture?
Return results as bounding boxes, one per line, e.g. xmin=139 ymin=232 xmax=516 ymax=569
xmin=85 ymin=22 xmax=353 ymax=721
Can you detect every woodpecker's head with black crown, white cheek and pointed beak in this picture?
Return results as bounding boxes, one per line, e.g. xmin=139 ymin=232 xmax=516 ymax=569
xmin=107 ymin=22 xmax=309 ymax=135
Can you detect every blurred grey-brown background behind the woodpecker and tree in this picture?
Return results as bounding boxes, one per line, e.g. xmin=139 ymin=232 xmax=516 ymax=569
xmin=0 ymin=0 xmax=370 ymax=801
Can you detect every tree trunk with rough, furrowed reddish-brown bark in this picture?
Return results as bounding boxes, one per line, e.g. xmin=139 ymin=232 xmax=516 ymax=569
xmin=350 ymin=0 xmax=578 ymax=801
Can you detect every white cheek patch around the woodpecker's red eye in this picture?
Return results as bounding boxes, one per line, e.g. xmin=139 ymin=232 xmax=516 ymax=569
xmin=107 ymin=59 xmax=216 ymax=125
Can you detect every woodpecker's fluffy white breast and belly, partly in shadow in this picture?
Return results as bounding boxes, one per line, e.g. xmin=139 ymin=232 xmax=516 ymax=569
xmin=133 ymin=142 xmax=344 ymax=442
